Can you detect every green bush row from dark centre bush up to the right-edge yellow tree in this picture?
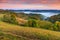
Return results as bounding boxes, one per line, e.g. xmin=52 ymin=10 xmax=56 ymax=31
xmin=27 ymin=19 xmax=54 ymax=30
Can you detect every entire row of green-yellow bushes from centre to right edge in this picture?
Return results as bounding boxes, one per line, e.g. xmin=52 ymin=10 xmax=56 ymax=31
xmin=25 ymin=19 xmax=60 ymax=31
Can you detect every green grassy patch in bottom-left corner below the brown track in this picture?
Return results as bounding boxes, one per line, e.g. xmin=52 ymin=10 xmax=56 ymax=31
xmin=0 ymin=31 xmax=24 ymax=40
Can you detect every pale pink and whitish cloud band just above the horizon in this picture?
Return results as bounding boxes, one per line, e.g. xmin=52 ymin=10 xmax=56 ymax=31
xmin=0 ymin=3 xmax=60 ymax=10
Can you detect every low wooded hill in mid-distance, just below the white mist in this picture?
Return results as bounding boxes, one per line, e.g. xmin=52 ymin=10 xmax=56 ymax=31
xmin=16 ymin=13 xmax=44 ymax=20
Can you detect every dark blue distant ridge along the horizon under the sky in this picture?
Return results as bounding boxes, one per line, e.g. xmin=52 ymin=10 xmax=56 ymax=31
xmin=10 ymin=10 xmax=60 ymax=13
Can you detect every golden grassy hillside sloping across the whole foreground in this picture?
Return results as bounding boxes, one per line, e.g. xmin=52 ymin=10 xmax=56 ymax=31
xmin=0 ymin=21 xmax=60 ymax=40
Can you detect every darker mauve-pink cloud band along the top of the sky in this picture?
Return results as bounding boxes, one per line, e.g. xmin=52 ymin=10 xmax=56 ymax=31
xmin=0 ymin=0 xmax=60 ymax=4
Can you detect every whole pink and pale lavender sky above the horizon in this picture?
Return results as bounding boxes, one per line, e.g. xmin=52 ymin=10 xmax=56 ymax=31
xmin=0 ymin=0 xmax=60 ymax=10
